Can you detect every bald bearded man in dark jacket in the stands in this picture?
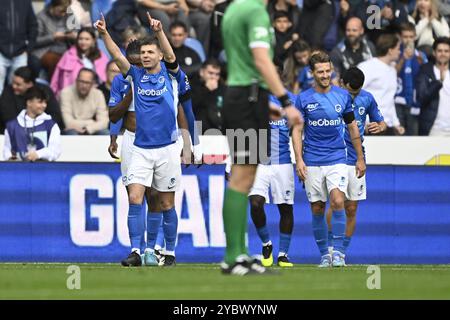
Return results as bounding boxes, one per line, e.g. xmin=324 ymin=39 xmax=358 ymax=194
xmin=330 ymin=17 xmax=375 ymax=77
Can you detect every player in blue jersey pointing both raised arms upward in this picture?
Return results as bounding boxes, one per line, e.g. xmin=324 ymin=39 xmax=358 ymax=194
xmin=95 ymin=13 xmax=190 ymax=266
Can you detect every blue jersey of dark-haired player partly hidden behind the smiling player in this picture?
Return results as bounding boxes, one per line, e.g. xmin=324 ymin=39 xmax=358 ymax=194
xmin=345 ymin=90 xmax=384 ymax=166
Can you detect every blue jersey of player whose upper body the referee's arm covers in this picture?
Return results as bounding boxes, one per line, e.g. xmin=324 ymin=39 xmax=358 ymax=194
xmin=269 ymin=91 xmax=297 ymax=164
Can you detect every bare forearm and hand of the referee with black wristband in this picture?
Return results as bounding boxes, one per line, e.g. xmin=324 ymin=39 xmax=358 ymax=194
xmin=252 ymin=47 xmax=302 ymax=126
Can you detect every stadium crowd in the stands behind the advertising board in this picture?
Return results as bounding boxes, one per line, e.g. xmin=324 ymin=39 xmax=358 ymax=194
xmin=0 ymin=0 xmax=450 ymax=160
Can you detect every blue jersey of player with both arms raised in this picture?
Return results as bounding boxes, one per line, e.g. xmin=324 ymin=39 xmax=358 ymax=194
xmin=127 ymin=62 xmax=181 ymax=149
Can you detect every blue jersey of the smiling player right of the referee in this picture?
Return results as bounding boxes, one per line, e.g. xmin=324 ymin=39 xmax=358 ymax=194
xmin=295 ymin=86 xmax=353 ymax=166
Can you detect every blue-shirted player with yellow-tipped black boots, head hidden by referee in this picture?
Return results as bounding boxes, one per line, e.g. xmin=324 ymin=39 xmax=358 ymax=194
xmin=249 ymin=91 xmax=298 ymax=267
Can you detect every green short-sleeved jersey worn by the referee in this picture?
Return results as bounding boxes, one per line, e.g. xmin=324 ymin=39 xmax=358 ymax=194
xmin=222 ymin=0 xmax=275 ymax=88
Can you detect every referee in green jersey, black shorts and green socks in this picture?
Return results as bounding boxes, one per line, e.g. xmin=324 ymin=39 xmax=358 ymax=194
xmin=221 ymin=0 xmax=301 ymax=276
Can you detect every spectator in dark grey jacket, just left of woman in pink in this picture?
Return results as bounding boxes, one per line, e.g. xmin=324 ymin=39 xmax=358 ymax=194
xmin=29 ymin=0 xmax=77 ymax=79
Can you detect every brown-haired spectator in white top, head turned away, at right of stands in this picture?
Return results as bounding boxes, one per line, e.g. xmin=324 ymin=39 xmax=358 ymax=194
xmin=358 ymin=33 xmax=405 ymax=135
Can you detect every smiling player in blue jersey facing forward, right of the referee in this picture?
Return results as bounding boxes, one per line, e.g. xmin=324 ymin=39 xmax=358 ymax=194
xmin=293 ymin=51 xmax=366 ymax=267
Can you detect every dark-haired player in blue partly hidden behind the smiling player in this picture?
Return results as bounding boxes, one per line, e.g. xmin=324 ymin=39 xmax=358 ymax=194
xmin=327 ymin=67 xmax=387 ymax=265
